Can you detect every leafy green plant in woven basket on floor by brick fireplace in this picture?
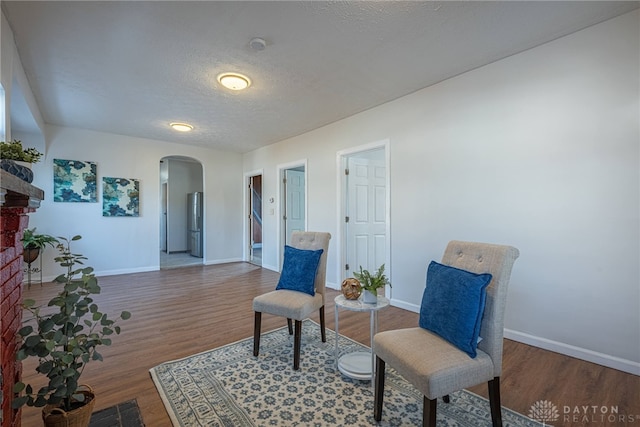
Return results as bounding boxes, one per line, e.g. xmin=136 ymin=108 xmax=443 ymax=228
xmin=12 ymin=236 xmax=131 ymax=427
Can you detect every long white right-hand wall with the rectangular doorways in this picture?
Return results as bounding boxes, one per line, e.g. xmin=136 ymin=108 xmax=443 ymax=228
xmin=244 ymin=11 xmax=640 ymax=374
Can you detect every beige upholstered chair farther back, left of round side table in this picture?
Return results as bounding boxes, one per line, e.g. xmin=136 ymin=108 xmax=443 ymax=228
xmin=253 ymin=231 xmax=331 ymax=370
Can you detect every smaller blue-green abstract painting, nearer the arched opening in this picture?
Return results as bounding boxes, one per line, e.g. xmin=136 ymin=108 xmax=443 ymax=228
xmin=102 ymin=177 xmax=140 ymax=216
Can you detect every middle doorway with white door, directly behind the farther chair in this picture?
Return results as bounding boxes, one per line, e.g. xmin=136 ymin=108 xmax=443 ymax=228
xmin=278 ymin=160 xmax=307 ymax=265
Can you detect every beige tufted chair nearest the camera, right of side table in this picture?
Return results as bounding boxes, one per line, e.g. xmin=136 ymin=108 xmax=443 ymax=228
xmin=373 ymin=241 xmax=519 ymax=427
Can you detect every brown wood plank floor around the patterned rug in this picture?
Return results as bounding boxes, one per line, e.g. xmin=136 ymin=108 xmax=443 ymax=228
xmin=17 ymin=263 xmax=640 ymax=427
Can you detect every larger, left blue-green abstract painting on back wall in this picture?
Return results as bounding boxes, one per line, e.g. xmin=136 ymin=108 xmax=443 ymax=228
xmin=53 ymin=159 xmax=98 ymax=203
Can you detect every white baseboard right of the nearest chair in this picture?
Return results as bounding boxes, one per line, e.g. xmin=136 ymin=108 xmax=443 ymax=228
xmin=504 ymin=329 xmax=640 ymax=375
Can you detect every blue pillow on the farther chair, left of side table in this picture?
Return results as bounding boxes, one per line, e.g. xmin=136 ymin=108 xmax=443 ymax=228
xmin=276 ymin=245 xmax=324 ymax=296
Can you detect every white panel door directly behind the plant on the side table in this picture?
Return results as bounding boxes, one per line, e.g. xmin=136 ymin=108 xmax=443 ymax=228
xmin=345 ymin=151 xmax=387 ymax=277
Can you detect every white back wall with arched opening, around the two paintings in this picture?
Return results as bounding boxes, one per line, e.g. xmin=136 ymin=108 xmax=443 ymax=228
xmin=29 ymin=127 xmax=242 ymax=280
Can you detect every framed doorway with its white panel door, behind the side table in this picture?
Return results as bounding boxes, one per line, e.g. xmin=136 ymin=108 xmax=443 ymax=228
xmin=338 ymin=141 xmax=391 ymax=297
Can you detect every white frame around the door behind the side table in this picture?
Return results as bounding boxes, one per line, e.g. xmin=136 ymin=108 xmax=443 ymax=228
xmin=336 ymin=139 xmax=392 ymax=298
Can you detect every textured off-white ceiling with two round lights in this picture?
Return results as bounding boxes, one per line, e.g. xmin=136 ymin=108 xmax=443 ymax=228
xmin=2 ymin=1 xmax=638 ymax=152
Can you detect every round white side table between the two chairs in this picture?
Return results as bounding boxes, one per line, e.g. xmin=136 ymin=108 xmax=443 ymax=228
xmin=334 ymin=295 xmax=390 ymax=380
